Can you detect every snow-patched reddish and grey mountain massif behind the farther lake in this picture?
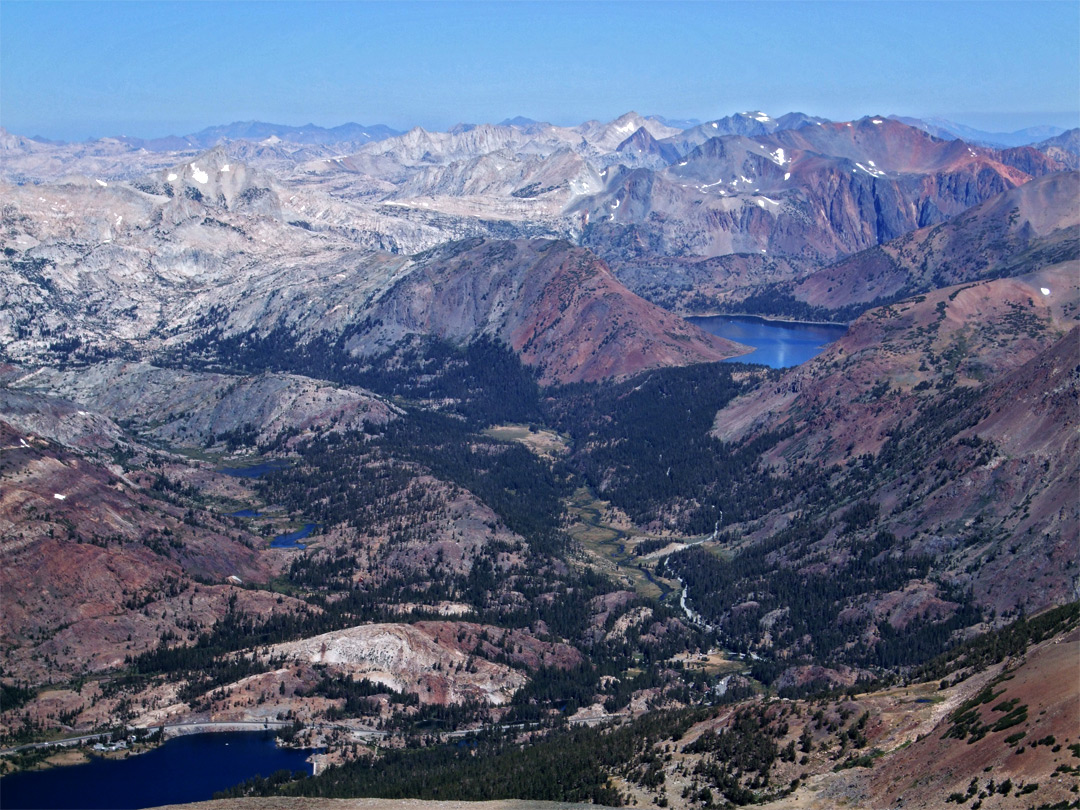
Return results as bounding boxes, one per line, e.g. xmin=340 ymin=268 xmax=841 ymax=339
xmin=571 ymin=118 xmax=1064 ymax=266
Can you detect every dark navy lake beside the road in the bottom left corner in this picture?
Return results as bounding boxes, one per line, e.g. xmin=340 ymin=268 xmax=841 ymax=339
xmin=0 ymin=732 xmax=311 ymax=810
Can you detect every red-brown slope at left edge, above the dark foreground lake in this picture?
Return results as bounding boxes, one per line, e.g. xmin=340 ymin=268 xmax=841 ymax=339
xmin=0 ymin=421 xmax=293 ymax=683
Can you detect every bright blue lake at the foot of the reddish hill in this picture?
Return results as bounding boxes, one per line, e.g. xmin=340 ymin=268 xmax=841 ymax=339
xmin=687 ymin=315 xmax=848 ymax=368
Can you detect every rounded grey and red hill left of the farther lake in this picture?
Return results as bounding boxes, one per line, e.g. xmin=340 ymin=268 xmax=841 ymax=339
xmin=349 ymin=240 xmax=744 ymax=383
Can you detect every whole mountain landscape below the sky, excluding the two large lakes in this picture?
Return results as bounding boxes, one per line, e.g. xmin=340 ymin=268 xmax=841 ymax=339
xmin=0 ymin=111 xmax=1080 ymax=810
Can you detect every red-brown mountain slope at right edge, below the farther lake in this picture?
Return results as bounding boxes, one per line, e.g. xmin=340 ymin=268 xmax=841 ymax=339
xmin=715 ymin=262 xmax=1080 ymax=612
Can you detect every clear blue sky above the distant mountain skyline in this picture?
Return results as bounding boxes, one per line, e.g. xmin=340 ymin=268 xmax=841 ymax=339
xmin=0 ymin=0 xmax=1080 ymax=139
